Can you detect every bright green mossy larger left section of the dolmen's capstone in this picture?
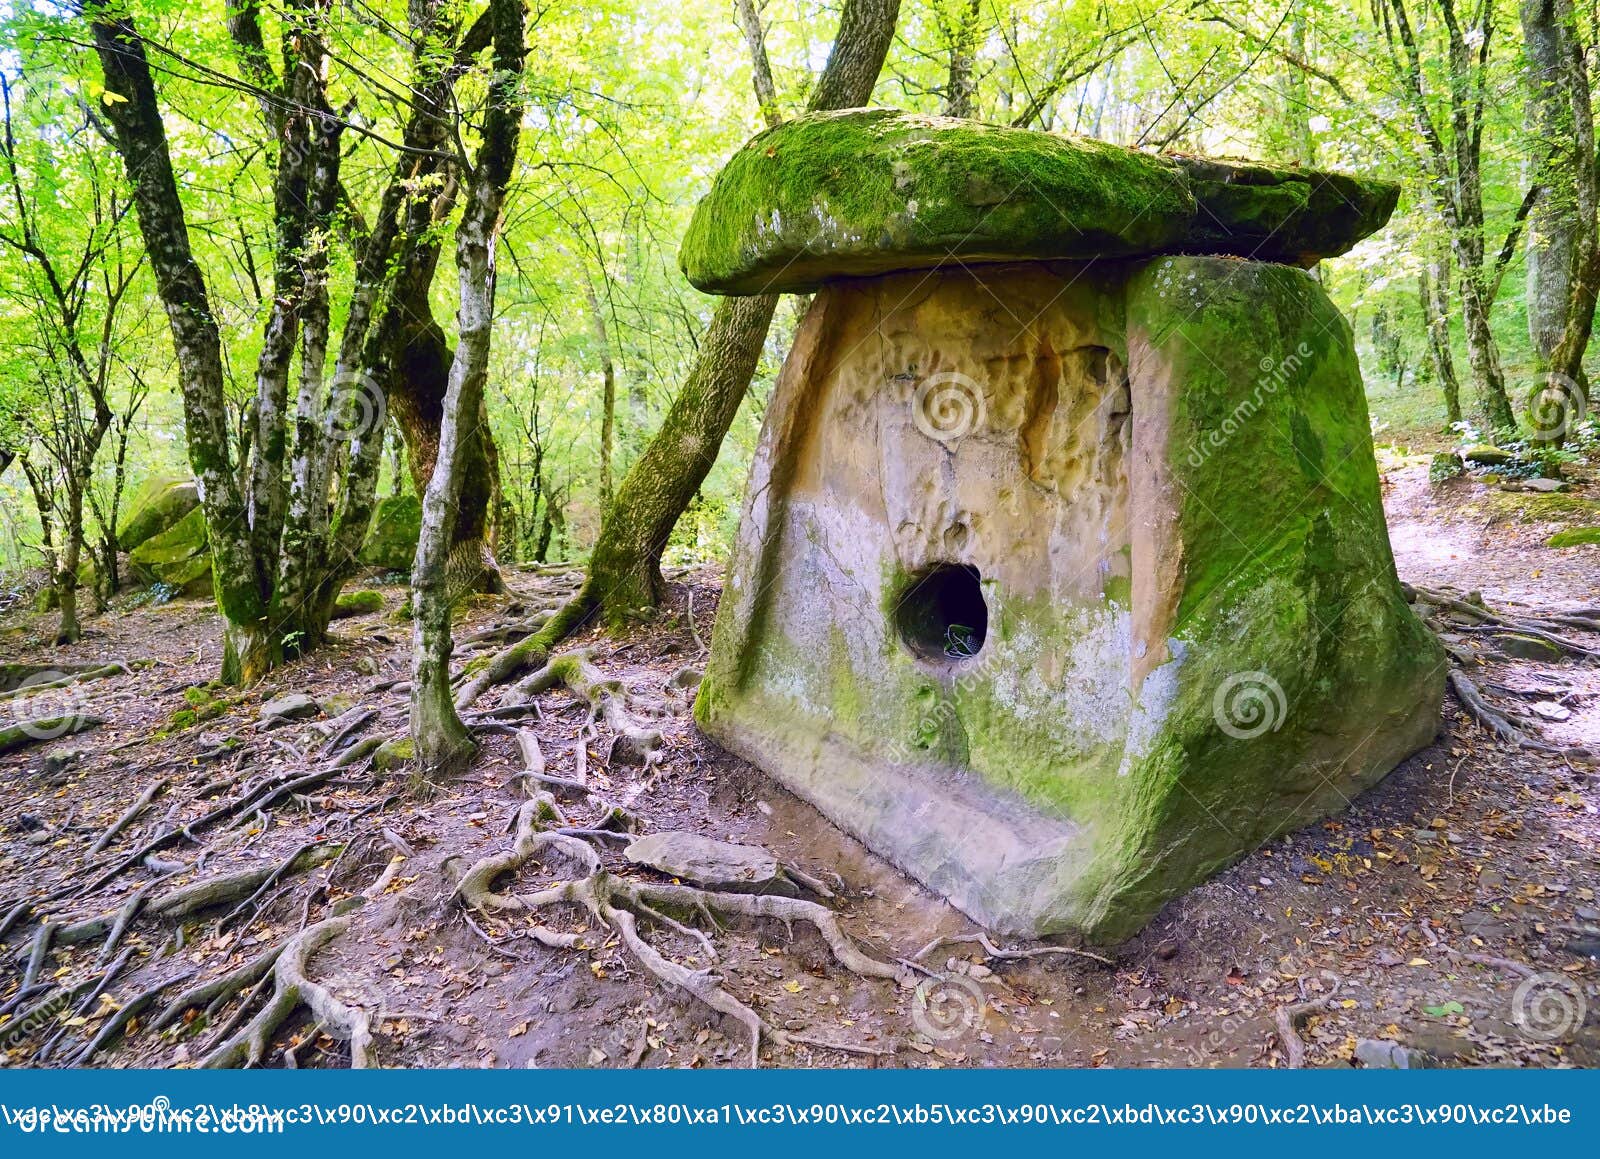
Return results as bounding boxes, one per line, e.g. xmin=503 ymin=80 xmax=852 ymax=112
xmin=678 ymin=109 xmax=1195 ymax=293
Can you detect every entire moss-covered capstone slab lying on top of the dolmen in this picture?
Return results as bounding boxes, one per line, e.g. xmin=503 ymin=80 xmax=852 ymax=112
xmin=678 ymin=109 xmax=1400 ymax=295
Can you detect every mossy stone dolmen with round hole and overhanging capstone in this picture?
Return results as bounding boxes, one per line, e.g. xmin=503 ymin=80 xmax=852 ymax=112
xmin=682 ymin=109 xmax=1445 ymax=941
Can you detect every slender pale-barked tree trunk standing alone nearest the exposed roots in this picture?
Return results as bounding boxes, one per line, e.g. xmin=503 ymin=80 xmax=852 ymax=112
xmin=411 ymin=0 xmax=523 ymax=780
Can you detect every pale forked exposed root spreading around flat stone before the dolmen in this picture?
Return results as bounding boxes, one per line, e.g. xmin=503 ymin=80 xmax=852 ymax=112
xmin=456 ymin=792 xmax=909 ymax=1066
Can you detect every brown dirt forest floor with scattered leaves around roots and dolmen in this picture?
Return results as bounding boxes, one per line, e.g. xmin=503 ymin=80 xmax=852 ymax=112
xmin=0 ymin=459 xmax=1600 ymax=1066
